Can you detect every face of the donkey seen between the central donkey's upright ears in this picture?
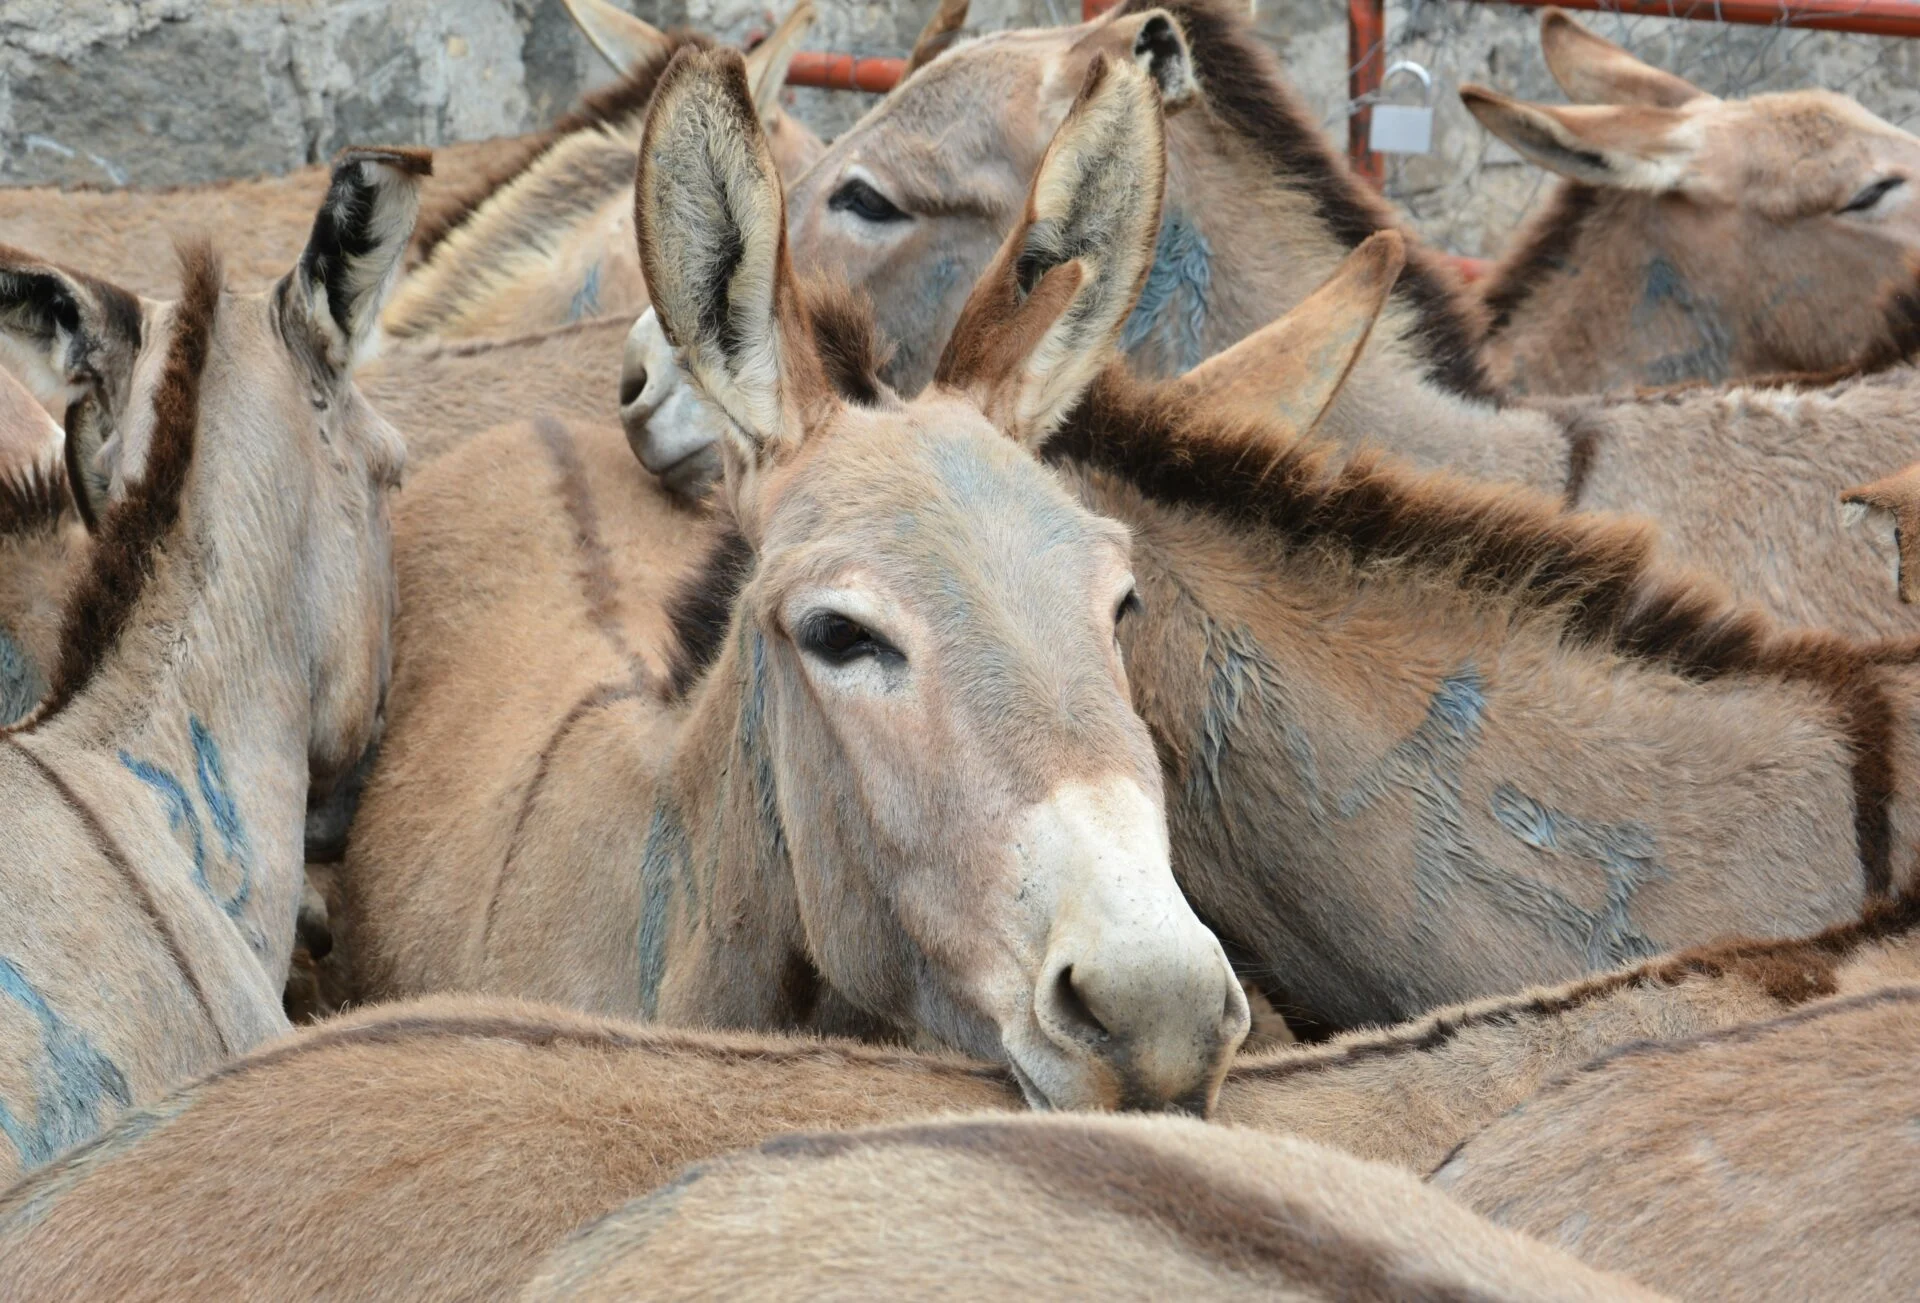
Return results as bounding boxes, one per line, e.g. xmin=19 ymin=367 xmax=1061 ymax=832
xmin=791 ymin=6 xmax=1198 ymax=391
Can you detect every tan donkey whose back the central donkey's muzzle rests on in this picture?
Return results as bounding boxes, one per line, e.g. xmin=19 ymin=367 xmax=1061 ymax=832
xmin=0 ymin=906 xmax=1920 ymax=1299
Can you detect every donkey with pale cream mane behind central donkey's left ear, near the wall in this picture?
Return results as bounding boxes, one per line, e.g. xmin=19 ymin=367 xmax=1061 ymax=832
xmin=382 ymin=0 xmax=822 ymax=340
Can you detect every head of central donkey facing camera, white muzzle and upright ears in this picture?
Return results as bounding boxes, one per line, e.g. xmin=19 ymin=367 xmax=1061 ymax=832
xmin=636 ymin=54 xmax=1248 ymax=1111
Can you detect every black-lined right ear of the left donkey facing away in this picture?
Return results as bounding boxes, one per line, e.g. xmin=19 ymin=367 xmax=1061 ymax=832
xmin=284 ymin=146 xmax=434 ymax=374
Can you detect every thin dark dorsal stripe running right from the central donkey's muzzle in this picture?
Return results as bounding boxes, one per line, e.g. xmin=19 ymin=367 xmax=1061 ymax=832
xmin=1233 ymin=898 xmax=1920 ymax=1080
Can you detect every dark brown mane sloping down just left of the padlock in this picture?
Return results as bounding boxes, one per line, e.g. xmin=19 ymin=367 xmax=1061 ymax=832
xmin=1121 ymin=0 xmax=1496 ymax=401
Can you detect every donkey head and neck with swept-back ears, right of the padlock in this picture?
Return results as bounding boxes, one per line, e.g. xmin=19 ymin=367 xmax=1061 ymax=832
xmin=1461 ymin=10 xmax=1920 ymax=393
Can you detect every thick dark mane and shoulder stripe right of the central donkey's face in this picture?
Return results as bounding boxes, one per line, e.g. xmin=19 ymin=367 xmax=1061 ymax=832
xmin=1046 ymin=367 xmax=1920 ymax=896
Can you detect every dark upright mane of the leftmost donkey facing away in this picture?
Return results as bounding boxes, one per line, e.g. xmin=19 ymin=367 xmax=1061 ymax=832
xmin=21 ymin=240 xmax=221 ymax=731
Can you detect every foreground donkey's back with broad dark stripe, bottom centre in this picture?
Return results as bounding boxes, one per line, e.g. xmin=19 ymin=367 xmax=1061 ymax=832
xmin=520 ymin=1117 xmax=1659 ymax=1303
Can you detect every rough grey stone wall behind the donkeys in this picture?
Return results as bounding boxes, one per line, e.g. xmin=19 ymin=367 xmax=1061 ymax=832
xmin=0 ymin=0 xmax=1920 ymax=253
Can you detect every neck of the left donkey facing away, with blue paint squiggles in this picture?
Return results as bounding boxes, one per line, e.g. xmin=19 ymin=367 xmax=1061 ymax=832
xmin=15 ymin=333 xmax=311 ymax=973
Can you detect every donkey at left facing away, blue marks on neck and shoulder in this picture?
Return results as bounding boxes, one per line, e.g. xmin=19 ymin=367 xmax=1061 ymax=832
xmin=0 ymin=150 xmax=428 ymax=1174
